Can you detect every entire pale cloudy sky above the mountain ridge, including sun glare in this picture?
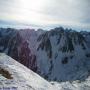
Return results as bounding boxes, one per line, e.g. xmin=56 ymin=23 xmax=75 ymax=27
xmin=0 ymin=0 xmax=90 ymax=30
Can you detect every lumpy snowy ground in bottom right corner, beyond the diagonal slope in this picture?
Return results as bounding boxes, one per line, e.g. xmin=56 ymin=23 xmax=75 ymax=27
xmin=51 ymin=76 xmax=90 ymax=90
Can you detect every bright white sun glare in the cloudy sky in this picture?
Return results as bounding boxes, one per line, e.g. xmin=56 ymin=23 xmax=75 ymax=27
xmin=16 ymin=0 xmax=44 ymax=23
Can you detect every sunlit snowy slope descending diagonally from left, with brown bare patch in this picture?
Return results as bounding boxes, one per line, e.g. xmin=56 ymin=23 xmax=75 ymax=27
xmin=0 ymin=53 xmax=58 ymax=90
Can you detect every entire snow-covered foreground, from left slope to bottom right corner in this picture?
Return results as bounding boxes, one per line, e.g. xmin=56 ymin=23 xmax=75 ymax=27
xmin=0 ymin=53 xmax=90 ymax=90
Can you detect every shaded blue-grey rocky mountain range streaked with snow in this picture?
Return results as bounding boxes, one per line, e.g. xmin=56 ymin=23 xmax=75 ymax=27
xmin=0 ymin=27 xmax=90 ymax=81
